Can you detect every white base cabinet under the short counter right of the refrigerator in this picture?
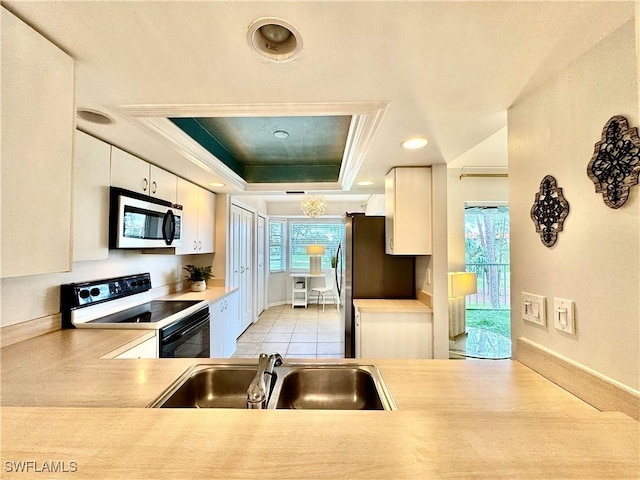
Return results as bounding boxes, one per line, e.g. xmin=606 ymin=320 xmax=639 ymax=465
xmin=355 ymin=307 xmax=433 ymax=358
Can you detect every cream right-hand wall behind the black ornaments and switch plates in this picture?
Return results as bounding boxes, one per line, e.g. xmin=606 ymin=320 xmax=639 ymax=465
xmin=508 ymin=21 xmax=640 ymax=389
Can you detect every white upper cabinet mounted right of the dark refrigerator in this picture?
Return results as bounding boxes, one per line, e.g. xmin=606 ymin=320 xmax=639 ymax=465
xmin=384 ymin=167 xmax=431 ymax=255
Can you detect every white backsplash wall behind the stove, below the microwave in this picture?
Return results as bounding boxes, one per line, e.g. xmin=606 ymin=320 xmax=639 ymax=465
xmin=0 ymin=250 xmax=212 ymax=326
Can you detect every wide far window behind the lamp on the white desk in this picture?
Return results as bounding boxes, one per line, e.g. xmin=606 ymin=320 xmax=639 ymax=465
xmin=289 ymin=220 xmax=344 ymax=270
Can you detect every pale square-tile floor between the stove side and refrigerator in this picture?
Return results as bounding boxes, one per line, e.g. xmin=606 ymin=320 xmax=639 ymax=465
xmin=233 ymin=305 xmax=344 ymax=358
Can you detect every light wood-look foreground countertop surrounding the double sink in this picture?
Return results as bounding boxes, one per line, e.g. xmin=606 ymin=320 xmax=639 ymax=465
xmin=0 ymin=316 xmax=640 ymax=479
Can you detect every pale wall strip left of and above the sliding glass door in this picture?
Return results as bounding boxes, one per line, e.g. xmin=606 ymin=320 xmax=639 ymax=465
xmin=447 ymin=171 xmax=509 ymax=272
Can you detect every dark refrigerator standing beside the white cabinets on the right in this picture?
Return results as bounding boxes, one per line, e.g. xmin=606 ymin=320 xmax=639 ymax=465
xmin=344 ymin=213 xmax=416 ymax=358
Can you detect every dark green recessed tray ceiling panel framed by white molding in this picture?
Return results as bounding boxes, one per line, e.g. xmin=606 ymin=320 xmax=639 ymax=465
xmin=169 ymin=115 xmax=351 ymax=183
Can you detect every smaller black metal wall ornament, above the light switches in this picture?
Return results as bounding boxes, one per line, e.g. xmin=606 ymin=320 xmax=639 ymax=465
xmin=531 ymin=175 xmax=569 ymax=247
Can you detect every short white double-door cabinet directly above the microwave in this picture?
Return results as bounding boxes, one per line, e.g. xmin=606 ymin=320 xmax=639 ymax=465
xmin=111 ymin=147 xmax=178 ymax=203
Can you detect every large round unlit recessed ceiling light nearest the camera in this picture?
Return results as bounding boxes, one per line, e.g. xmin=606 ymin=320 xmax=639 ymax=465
xmin=247 ymin=18 xmax=302 ymax=62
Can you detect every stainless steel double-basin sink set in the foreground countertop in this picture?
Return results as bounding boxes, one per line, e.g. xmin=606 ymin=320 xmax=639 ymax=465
xmin=149 ymin=363 xmax=397 ymax=410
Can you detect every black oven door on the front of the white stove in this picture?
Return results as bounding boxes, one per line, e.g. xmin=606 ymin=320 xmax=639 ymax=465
xmin=159 ymin=306 xmax=211 ymax=358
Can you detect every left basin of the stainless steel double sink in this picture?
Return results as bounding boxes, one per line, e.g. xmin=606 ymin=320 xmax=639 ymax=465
xmin=149 ymin=365 xmax=266 ymax=408
